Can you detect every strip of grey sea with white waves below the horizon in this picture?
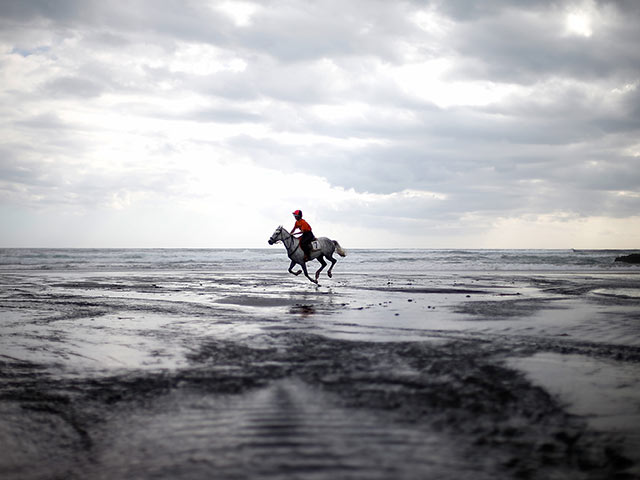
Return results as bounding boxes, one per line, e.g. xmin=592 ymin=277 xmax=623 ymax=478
xmin=0 ymin=246 xmax=640 ymax=273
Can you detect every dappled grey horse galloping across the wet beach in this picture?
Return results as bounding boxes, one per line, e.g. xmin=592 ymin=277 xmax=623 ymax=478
xmin=269 ymin=225 xmax=347 ymax=285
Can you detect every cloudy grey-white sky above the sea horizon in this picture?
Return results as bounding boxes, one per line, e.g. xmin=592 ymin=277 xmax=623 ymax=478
xmin=0 ymin=0 xmax=640 ymax=249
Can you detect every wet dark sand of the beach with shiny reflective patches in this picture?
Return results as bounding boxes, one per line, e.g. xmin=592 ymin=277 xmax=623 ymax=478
xmin=0 ymin=270 xmax=640 ymax=479
